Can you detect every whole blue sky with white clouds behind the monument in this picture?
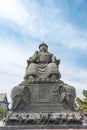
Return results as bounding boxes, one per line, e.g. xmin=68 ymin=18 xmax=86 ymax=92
xmin=0 ymin=0 xmax=87 ymax=102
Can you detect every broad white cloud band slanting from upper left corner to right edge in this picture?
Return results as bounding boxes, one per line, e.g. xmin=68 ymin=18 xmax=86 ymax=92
xmin=0 ymin=0 xmax=87 ymax=49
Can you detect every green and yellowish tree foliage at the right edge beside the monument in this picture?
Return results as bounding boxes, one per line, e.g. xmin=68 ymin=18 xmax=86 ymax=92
xmin=76 ymin=90 xmax=87 ymax=112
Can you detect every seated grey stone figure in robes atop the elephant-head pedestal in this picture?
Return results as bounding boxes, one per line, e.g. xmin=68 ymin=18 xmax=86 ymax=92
xmin=24 ymin=43 xmax=61 ymax=79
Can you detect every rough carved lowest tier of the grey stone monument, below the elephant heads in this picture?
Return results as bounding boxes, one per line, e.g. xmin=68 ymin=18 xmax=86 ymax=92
xmin=5 ymin=112 xmax=82 ymax=126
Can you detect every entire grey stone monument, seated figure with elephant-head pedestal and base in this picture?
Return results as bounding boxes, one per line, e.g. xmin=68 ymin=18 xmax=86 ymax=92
xmin=6 ymin=43 xmax=81 ymax=126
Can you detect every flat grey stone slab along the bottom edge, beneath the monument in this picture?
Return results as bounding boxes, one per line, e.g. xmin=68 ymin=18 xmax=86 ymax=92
xmin=0 ymin=125 xmax=87 ymax=130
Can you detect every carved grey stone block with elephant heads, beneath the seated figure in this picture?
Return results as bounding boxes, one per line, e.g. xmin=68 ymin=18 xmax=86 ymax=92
xmin=12 ymin=80 xmax=75 ymax=113
